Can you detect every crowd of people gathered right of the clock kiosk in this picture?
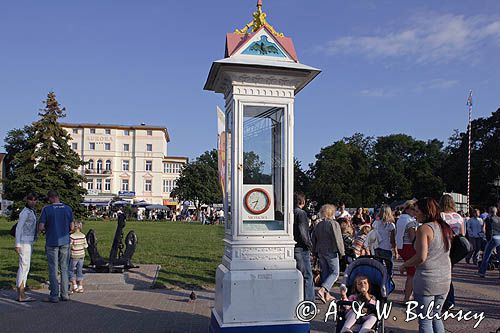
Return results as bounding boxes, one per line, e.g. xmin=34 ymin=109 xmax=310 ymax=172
xmin=294 ymin=193 xmax=500 ymax=332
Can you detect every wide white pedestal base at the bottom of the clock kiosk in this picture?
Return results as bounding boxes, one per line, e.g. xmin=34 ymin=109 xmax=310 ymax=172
xmin=210 ymin=265 xmax=309 ymax=332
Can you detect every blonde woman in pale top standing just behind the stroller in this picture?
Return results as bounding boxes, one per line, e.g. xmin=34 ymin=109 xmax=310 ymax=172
xmin=373 ymin=205 xmax=396 ymax=276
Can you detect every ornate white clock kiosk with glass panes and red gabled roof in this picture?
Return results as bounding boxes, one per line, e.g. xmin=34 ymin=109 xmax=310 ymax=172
xmin=205 ymin=0 xmax=320 ymax=333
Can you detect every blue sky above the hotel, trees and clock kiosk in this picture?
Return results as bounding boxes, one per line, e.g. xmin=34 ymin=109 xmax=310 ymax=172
xmin=0 ymin=0 xmax=500 ymax=165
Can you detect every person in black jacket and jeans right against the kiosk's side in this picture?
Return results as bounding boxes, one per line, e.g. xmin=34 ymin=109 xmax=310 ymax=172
xmin=293 ymin=193 xmax=314 ymax=302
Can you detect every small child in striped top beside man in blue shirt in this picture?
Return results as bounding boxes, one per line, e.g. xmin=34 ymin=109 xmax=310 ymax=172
xmin=69 ymin=222 xmax=88 ymax=293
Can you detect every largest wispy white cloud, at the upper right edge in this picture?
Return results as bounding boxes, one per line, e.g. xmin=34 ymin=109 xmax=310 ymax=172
xmin=317 ymin=14 xmax=500 ymax=63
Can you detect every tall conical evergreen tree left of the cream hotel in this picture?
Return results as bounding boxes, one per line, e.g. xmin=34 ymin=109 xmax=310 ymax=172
xmin=5 ymin=92 xmax=85 ymax=218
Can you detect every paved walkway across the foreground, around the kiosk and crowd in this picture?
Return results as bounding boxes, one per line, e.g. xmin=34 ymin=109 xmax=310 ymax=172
xmin=0 ymin=264 xmax=500 ymax=333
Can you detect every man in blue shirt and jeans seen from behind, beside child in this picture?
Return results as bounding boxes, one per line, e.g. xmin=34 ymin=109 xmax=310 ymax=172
xmin=39 ymin=191 xmax=73 ymax=303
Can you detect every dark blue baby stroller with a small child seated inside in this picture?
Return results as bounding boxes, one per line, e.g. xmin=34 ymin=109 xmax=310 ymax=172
xmin=336 ymin=256 xmax=395 ymax=333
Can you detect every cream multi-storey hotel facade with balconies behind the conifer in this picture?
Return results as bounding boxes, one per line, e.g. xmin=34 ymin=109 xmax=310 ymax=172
xmin=61 ymin=123 xmax=188 ymax=206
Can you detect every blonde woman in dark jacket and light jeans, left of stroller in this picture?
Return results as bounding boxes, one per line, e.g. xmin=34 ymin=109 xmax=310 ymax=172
xmin=311 ymin=205 xmax=345 ymax=303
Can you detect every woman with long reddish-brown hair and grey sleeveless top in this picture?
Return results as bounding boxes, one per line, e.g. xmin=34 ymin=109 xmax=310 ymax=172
xmin=399 ymin=198 xmax=453 ymax=333
